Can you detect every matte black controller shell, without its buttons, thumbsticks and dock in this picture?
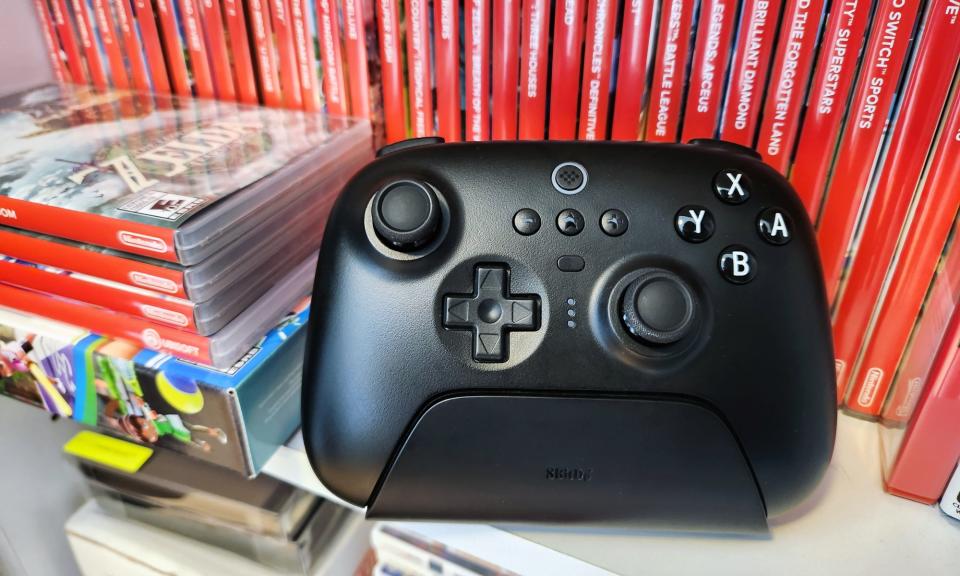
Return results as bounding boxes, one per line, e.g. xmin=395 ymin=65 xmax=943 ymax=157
xmin=303 ymin=142 xmax=836 ymax=524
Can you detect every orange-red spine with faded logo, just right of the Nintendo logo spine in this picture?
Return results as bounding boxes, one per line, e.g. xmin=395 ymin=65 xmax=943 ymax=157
xmin=881 ymin=230 xmax=960 ymax=427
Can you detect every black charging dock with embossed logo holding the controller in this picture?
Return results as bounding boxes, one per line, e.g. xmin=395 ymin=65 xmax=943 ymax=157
xmin=367 ymin=396 xmax=767 ymax=532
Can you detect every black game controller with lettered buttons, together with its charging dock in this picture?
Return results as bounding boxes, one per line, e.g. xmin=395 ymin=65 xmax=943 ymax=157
xmin=303 ymin=139 xmax=836 ymax=532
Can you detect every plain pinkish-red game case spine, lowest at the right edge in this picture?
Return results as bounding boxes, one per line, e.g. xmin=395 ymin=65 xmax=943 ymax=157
xmin=884 ymin=306 xmax=960 ymax=504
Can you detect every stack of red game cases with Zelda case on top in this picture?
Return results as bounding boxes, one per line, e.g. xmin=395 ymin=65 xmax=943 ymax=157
xmin=0 ymin=86 xmax=372 ymax=366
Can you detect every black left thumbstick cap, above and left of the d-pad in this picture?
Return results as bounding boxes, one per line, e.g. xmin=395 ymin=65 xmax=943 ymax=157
xmin=373 ymin=180 xmax=441 ymax=251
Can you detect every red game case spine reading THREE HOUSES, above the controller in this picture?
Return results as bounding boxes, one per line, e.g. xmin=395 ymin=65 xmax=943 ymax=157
xmin=519 ymin=0 xmax=550 ymax=140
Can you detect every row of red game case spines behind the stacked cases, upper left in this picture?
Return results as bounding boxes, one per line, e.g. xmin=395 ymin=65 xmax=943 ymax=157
xmin=34 ymin=0 xmax=373 ymax=117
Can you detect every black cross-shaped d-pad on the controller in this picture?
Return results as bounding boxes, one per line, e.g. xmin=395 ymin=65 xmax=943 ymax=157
xmin=443 ymin=264 xmax=540 ymax=362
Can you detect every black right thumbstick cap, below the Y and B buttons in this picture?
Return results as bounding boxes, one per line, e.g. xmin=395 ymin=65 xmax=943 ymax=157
xmin=622 ymin=269 xmax=695 ymax=345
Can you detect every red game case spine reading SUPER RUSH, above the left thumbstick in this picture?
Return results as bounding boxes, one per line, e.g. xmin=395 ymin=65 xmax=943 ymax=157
xmin=376 ymin=0 xmax=404 ymax=143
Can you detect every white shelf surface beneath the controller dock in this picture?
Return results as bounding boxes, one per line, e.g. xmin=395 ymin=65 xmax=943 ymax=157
xmin=265 ymin=416 xmax=960 ymax=576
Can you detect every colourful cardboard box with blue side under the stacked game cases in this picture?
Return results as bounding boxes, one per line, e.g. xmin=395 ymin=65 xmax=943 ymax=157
xmin=0 ymin=300 xmax=309 ymax=476
